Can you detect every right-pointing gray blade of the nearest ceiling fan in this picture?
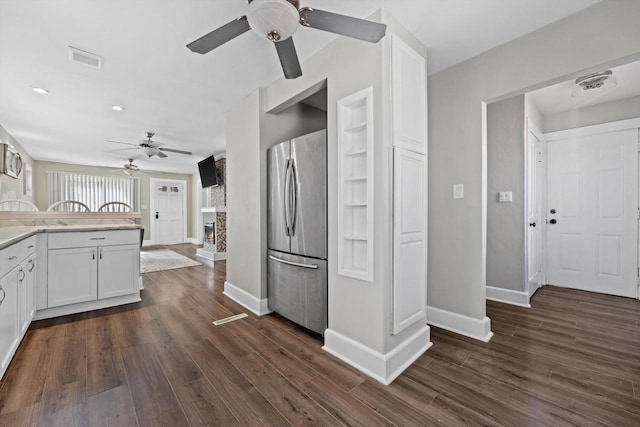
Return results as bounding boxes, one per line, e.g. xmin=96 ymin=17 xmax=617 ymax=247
xmin=300 ymin=7 xmax=387 ymax=43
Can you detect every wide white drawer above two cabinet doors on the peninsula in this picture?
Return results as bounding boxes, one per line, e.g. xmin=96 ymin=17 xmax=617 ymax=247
xmin=49 ymin=228 xmax=140 ymax=249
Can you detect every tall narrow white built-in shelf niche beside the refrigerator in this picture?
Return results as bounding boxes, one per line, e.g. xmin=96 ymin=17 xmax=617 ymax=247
xmin=337 ymin=87 xmax=373 ymax=282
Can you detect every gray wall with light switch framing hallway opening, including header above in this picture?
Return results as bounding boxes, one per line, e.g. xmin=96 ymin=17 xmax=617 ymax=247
xmin=428 ymin=0 xmax=640 ymax=320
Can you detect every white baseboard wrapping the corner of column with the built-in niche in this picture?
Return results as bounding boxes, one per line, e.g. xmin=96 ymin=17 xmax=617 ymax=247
xmin=322 ymin=325 xmax=432 ymax=385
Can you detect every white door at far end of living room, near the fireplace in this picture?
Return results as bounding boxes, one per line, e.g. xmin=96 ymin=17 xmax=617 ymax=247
xmin=152 ymin=181 xmax=185 ymax=245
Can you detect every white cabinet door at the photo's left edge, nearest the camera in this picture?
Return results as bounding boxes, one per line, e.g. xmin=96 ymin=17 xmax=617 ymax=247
xmin=0 ymin=267 xmax=19 ymax=378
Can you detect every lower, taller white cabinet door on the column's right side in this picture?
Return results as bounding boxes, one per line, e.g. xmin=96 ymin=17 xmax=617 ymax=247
xmin=392 ymin=148 xmax=427 ymax=334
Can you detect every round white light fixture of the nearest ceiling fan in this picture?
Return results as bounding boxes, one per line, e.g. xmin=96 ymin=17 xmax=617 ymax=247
xmin=247 ymin=0 xmax=300 ymax=42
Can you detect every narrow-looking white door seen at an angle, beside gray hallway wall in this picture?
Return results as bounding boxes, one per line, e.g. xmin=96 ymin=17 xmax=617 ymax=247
xmin=527 ymin=123 xmax=544 ymax=296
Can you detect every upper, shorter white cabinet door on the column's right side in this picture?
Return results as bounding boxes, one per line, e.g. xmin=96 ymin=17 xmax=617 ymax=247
xmin=391 ymin=35 xmax=427 ymax=154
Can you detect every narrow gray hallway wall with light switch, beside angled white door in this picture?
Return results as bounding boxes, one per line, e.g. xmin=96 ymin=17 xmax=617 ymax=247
xmin=487 ymin=95 xmax=526 ymax=292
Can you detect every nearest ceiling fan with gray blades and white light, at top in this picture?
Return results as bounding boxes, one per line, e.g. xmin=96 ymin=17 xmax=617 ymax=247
xmin=187 ymin=0 xmax=387 ymax=79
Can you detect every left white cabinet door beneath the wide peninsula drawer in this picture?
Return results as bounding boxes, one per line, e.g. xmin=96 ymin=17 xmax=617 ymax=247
xmin=47 ymin=248 xmax=98 ymax=308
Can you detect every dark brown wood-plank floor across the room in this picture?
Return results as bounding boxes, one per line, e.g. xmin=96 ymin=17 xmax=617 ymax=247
xmin=0 ymin=245 xmax=640 ymax=427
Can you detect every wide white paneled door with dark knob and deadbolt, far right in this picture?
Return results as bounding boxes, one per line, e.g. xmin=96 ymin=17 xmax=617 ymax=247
xmin=547 ymin=129 xmax=638 ymax=298
